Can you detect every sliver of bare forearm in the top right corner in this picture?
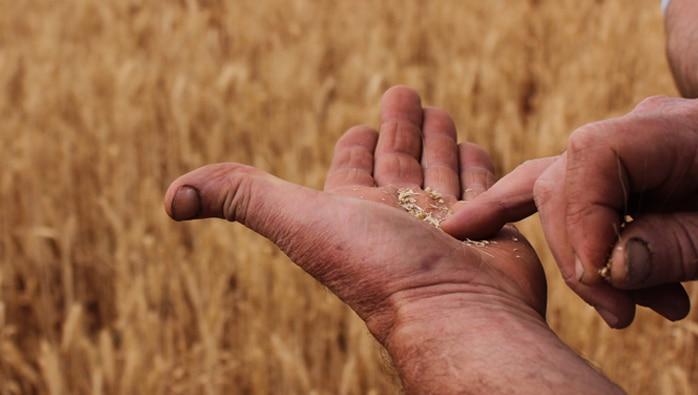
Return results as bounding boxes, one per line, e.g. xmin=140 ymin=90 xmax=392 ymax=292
xmin=665 ymin=0 xmax=698 ymax=98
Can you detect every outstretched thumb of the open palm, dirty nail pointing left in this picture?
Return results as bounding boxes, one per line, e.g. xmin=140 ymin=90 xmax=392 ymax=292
xmin=165 ymin=163 xmax=334 ymax=254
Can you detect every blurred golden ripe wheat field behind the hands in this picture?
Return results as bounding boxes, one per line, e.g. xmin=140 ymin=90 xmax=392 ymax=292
xmin=0 ymin=0 xmax=698 ymax=395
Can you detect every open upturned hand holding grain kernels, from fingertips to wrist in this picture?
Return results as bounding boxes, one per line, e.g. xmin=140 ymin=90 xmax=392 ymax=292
xmin=165 ymin=87 xmax=546 ymax=341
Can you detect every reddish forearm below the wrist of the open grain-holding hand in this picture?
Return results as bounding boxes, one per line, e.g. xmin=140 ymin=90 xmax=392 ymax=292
xmin=386 ymin=295 xmax=623 ymax=394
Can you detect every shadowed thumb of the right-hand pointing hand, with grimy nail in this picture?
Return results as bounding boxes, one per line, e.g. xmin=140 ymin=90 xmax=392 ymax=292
xmin=606 ymin=212 xmax=698 ymax=289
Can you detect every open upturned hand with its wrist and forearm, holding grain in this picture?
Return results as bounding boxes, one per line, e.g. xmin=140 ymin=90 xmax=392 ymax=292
xmin=165 ymin=87 xmax=620 ymax=394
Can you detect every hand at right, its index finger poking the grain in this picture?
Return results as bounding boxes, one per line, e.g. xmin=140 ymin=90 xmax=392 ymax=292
xmin=442 ymin=97 xmax=698 ymax=328
